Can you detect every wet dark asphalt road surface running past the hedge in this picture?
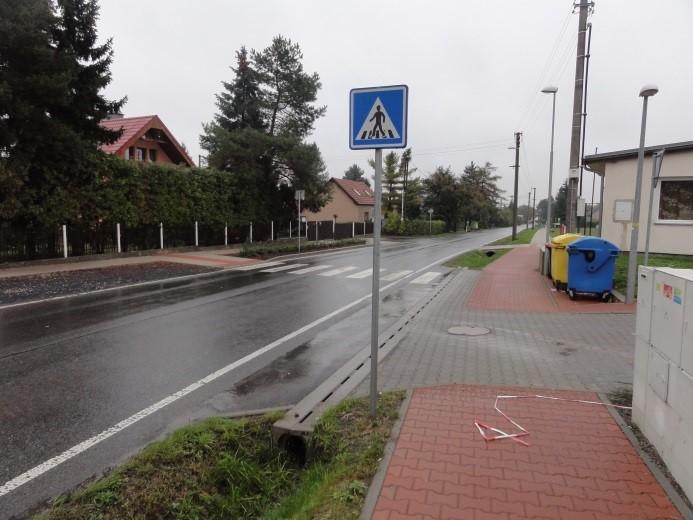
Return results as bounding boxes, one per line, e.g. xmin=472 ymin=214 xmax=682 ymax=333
xmin=0 ymin=230 xmax=509 ymax=518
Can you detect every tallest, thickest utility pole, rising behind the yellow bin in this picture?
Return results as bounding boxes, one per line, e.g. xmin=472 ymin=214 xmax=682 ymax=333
xmin=565 ymin=0 xmax=594 ymax=233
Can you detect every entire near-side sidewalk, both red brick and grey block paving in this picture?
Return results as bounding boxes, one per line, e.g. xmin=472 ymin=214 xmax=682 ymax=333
xmin=355 ymin=246 xmax=681 ymax=520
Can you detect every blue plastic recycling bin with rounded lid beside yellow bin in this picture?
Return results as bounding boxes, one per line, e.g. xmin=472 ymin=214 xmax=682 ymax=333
xmin=566 ymin=237 xmax=620 ymax=301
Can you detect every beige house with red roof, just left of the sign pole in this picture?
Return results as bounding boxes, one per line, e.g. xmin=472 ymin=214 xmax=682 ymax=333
xmin=304 ymin=178 xmax=375 ymax=223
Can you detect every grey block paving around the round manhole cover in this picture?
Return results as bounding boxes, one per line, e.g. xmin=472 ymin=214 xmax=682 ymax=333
xmin=356 ymin=268 xmax=635 ymax=395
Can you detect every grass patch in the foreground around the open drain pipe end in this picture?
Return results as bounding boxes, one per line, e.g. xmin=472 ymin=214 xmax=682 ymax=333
xmin=36 ymin=392 xmax=404 ymax=520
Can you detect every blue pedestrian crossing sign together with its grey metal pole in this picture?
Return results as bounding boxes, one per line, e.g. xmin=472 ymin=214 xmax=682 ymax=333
xmin=349 ymin=85 xmax=409 ymax=417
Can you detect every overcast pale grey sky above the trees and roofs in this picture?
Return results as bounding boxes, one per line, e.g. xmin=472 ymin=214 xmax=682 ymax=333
xmin=99 ymin=0 xmax=693 ymax=203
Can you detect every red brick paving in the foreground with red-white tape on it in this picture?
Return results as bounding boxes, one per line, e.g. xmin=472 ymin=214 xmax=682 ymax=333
xmin=373 ymin=385 xmax=681 ymax=520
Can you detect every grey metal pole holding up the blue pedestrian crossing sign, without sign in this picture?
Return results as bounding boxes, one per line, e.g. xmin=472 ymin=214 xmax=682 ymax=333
xmin=370 ymin=148 xmax=383 ymax=417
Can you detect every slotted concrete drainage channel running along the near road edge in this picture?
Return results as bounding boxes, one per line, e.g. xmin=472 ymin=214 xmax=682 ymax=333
xmin=272 ymin=273 xmax=452 ymax=462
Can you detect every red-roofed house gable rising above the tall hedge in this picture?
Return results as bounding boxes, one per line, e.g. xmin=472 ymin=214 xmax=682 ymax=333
xmin=100 ymin=114 xmax=195 ymax=166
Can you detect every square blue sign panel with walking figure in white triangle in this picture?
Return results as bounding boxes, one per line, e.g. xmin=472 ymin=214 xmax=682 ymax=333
xmin=349 ymin=85 xmax=409 ymax=150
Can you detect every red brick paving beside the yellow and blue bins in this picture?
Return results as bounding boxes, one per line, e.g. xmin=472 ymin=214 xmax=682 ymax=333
xmin=466 ymin=247 xmax=635 ymax=313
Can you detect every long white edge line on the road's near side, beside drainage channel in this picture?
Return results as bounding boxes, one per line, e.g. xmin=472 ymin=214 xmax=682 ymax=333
xmin=0 ymin=244 xmax=466 ymax=497
